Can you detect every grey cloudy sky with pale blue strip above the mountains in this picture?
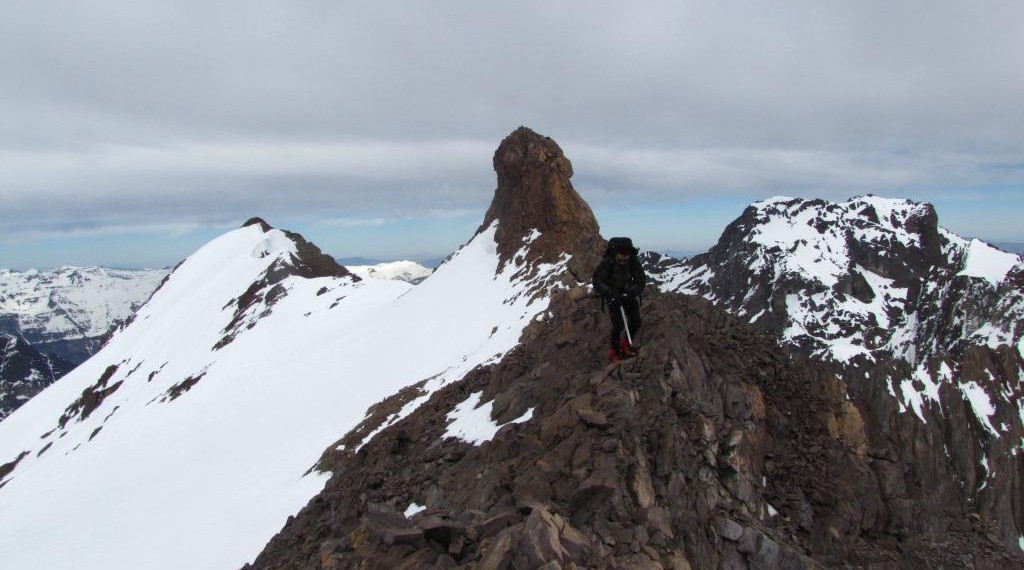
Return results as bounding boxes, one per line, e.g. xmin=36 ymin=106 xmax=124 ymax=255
xmin=0 ymin=0 xmax=1024 ymax=269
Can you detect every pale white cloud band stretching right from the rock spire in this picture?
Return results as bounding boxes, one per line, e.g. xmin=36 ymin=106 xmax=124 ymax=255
xmin=573 ymin=146 xmax=1024 ymax=200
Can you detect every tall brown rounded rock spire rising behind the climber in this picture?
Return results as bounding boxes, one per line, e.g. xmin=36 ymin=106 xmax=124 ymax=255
xmin=478 ymin=127 xmax=603 ymax=280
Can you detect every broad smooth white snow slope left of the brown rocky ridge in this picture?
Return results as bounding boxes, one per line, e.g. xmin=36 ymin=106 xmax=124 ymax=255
xmin=0 ymin=220 xmax=563 ymax=570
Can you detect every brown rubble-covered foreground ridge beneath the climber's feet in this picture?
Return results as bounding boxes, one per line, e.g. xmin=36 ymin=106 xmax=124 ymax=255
xmin=248 ymin=290 xmax=1021 ymax=569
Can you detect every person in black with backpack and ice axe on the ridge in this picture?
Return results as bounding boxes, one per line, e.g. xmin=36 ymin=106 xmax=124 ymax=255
xmin=593 ymin=237 xmax=647 ymax=362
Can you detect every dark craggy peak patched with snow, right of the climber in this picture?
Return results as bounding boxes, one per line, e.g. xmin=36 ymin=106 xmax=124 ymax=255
xmin=662 ymin=195 xmax=1024 ymax=468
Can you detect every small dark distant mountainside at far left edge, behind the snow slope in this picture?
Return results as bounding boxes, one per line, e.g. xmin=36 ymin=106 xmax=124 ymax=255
xmin=0 ymin=333 xmax=75 ymax=420
